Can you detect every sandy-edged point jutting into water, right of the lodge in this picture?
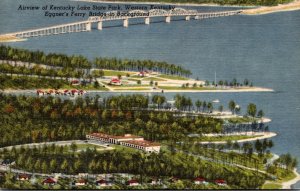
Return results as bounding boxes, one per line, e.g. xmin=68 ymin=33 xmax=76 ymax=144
xmin=199 ymin=132 xmax=277 ymax=144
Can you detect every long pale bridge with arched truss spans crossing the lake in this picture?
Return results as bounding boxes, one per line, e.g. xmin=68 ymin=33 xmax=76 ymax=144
xmin=1 ymin=8 xmax=241 ymax=38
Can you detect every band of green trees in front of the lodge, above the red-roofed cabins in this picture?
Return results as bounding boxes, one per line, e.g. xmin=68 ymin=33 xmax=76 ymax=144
xmin=0 ymin=145 xmax=265 ymax=188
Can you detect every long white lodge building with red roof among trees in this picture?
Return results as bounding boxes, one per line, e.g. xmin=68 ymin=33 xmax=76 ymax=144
xmin=86 ymin=133 xmax=160 ymax=153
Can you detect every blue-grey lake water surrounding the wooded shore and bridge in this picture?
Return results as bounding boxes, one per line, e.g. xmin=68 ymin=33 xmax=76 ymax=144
xmin=0 ymin=0 xmax=300 ymax=188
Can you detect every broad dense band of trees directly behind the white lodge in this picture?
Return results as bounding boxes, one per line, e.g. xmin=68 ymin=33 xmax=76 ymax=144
xmin=0 ymin=94 xmax=223 ymax=146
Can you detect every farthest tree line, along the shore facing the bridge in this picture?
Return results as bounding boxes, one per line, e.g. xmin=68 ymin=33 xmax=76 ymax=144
xmin=0 ymin=45 xmax=191 ymax=76
